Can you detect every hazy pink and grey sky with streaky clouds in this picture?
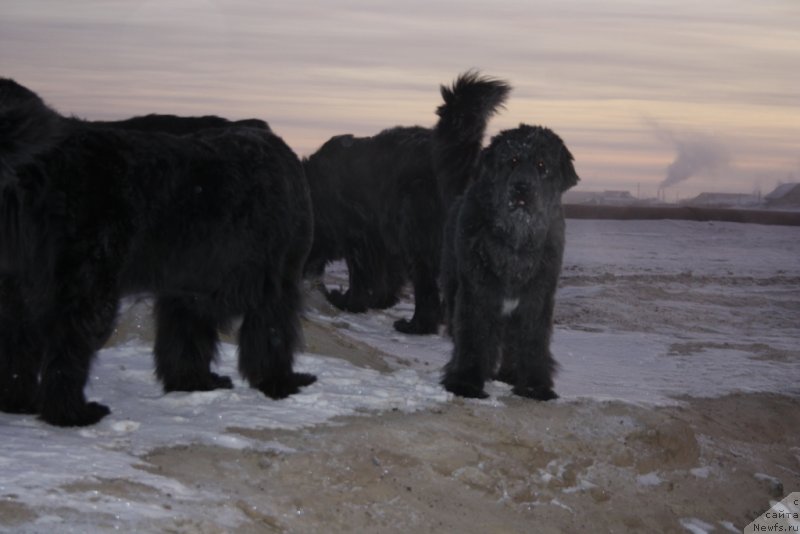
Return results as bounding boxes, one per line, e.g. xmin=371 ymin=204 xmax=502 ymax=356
xmin=0 ymin=0 xmax=800 ymax=200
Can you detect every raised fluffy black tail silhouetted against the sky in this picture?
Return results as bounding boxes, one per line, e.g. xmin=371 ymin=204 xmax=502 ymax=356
xmin=433 ymin=70 xmax=511 ymax=208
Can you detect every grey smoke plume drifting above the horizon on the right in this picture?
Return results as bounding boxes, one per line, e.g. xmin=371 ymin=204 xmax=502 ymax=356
xmin=646 ymin=120 xmax=731 ymax=189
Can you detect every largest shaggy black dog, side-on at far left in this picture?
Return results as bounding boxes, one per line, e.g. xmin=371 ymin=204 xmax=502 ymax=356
xmin=0 ymin=79 xmax=315 ymax=426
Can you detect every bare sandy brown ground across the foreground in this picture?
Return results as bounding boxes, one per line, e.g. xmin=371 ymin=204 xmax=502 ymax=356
xmin=0 ymin=275 xmax=800 ymax=533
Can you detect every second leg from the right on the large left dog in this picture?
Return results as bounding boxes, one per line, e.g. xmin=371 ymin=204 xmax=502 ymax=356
xmin=154 ymin=296 xmax=233 ymax=392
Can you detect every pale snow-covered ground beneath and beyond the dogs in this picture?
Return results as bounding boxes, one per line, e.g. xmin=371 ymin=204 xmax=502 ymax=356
xmin=0 ymin=220 xmax=800 ymax=532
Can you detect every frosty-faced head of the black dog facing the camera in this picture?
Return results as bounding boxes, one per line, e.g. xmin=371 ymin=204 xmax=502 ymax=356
xmin=481 ymin=124 xmax=578 ymax=223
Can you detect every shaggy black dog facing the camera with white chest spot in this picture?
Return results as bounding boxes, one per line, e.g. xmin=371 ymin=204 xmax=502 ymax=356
xmin=436 ymin=113 xmax=578 ymax=400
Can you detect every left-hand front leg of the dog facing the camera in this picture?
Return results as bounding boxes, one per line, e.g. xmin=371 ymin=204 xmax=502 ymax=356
xmin=441 ymin=284 xmax=501 ymax=399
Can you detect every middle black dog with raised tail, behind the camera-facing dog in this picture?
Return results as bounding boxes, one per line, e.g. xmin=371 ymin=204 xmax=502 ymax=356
xmin=304 ymin=72 xmax=509 ymax=334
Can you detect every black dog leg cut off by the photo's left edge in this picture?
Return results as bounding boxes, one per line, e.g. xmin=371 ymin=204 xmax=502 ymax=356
xmin=0 ymin=276 xmax=44 ymax=413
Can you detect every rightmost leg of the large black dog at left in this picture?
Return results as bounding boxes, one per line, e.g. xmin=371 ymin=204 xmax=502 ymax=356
xmin=239 ymin=272 xmax=317 ymax=399
